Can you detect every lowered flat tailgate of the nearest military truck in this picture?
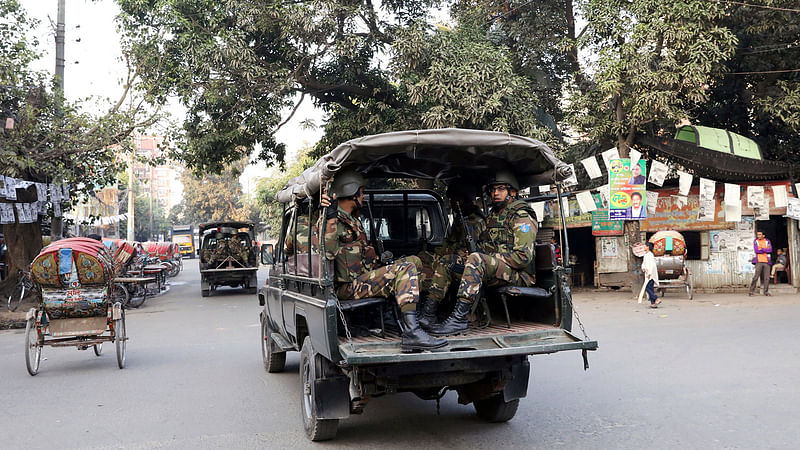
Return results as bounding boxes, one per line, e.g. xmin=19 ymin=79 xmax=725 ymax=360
xmin=339 ymin=322 xmax=597 ymax=365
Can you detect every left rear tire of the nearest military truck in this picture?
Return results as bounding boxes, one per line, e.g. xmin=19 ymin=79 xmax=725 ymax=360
xmin=300 ymin=336 xmax=339 ymax=441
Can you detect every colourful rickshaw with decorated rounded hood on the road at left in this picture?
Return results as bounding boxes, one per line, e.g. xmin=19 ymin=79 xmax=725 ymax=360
xmin=25 ymin=238 xmax=128 ymax=376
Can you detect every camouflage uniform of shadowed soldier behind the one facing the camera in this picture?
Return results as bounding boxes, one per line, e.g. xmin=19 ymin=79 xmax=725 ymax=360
xmin=421 ymin=207 xmax=486 ymax=302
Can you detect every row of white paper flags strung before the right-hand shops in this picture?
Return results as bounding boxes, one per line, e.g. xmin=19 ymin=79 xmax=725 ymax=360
xmin=532 ymin=148 xmax=800 ymax=222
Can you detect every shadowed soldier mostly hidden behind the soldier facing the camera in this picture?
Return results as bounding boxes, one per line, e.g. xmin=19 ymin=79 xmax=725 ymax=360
xmin=419 ymin=180 xmax=486 ymax=330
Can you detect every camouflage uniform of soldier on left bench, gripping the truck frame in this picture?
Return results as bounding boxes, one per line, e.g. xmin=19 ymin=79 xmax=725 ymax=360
xmin=325 ymin=208 xmax=422 ymax=307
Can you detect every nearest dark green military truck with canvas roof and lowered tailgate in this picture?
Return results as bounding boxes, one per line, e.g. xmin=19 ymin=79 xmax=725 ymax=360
xmin=258 ymin=129 xmax=598 ymax=441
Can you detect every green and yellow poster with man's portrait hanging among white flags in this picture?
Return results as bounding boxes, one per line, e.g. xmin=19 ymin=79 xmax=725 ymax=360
xmin=608 ymin=158 xmax=647 ymax=220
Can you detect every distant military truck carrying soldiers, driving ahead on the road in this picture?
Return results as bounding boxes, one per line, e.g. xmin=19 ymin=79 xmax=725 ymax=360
xmin=197 ymin=222 xmax=258 ymax=297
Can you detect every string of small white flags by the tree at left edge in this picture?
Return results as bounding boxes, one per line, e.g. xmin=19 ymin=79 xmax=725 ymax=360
xmin=0 ymin=175 xmax=70 ymax=224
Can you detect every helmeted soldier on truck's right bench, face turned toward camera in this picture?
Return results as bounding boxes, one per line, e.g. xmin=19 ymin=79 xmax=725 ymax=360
xmin=431 ymin=171 xmax=538 ymax=336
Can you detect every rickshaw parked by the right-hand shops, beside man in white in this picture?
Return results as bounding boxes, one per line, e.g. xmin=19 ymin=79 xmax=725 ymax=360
xmin=649 ymin=230 xmax=694 ymax=300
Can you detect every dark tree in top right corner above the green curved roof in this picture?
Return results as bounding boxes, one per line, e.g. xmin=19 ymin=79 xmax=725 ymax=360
xmin=692 ymin=0 xmax=800 ymax=164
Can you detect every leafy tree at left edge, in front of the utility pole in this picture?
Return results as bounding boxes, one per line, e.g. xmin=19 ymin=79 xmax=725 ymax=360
xmin=0 ymin=0 xmax=155 ymax=287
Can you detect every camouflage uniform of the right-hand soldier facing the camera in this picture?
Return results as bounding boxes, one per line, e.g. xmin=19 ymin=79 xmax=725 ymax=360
xmin=457 ymin=200 xmax=538 ymax=303
